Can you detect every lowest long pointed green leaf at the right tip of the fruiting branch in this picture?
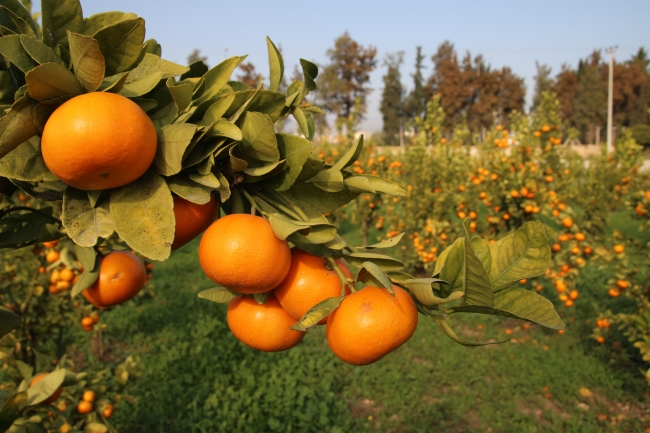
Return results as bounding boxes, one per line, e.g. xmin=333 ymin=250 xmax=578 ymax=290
xmin=451 ymin=287 xmax=565 ymax=329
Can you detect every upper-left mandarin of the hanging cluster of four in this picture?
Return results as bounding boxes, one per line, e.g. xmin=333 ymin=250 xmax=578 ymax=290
xmin=199 ymin=214 xmax=291 ymax=294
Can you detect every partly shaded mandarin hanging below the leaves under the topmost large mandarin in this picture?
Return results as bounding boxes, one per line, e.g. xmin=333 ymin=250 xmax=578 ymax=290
xmin=82 ymin=251 xmax=146 ymax=308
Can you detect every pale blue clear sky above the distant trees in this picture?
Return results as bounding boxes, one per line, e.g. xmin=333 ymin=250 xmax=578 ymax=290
xmin=41 ymin=0 xmax=650 ymax=131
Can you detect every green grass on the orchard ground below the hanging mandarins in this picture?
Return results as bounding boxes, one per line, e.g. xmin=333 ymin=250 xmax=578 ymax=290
xmin=82 ymin=241 xmax=650 ymax=432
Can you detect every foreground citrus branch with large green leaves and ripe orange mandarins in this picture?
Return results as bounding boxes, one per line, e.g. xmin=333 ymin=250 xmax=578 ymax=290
xmin=0 ymin=0 xmax=564 ymax=428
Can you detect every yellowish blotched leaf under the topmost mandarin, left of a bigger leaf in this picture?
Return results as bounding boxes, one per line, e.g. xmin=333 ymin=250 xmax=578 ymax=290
xmin=61 ymin=187 xmax=115 ymax=247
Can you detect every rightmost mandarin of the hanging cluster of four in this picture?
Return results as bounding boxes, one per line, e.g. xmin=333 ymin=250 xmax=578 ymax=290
xmin=326 ymin=286 xmax=418 ymax=365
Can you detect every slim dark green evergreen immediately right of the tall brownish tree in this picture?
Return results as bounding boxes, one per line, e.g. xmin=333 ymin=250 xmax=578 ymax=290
xmin=379 ymin=51 xmax=404 ymax=145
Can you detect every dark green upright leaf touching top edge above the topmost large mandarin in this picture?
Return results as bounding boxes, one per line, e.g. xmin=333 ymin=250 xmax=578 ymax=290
xmin=41 ymin=0 xmax=84 ymax=48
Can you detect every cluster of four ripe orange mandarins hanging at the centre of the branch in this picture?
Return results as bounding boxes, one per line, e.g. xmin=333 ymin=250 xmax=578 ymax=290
xmin=199 ymin=214 xmax=418 ymax=365
